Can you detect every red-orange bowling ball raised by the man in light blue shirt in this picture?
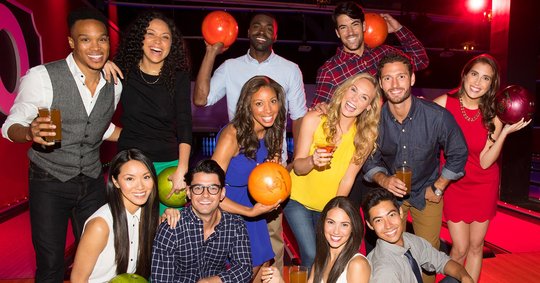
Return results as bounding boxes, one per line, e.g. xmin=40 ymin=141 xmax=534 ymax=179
xmin=202 ymin=11 xmax=238 ymax=47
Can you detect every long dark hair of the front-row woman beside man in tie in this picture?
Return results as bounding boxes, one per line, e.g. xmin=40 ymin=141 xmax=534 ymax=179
xmin=313 ymin=196 xmax=364 ymax=283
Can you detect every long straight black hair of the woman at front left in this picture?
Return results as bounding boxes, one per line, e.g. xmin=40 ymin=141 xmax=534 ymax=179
xmin=107 ymin=149 xmax=159 ymax=278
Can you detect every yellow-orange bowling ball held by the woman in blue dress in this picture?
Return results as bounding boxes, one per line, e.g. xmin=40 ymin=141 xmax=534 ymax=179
xmin=248 ymin=162 xmax=291 ymax=205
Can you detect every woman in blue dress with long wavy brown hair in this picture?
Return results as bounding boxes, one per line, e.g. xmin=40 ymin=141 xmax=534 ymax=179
xmin=212 ymin=76 xmax=286 ymax=278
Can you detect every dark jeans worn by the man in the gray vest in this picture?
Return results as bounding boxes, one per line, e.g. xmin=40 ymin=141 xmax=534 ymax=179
xmin=28 ymin=162 xmax=105 ymax=282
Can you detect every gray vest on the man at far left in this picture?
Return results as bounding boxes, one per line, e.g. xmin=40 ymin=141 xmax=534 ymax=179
xmin=28 ymin=60 xmax=114 ymax=182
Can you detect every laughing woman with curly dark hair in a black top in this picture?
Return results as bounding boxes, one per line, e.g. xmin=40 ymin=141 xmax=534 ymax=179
xmin=114 ymin=11 xmax=192 ymax=215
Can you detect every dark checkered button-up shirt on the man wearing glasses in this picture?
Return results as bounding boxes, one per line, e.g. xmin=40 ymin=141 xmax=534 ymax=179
xmin=151 ymin=207 xmax=252 ymax=283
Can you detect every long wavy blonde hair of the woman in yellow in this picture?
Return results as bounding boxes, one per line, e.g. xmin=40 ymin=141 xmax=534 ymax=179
xmin=323 ymin=73 xmax=382 ymax=164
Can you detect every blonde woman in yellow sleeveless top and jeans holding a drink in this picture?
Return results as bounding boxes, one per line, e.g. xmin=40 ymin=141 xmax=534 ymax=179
xmin=284 ymin=73 xmax=381 ymax=267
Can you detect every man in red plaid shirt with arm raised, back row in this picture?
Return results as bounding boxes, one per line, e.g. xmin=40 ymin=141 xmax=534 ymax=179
xmin=312 ymin=1 xmax=429 ymax=108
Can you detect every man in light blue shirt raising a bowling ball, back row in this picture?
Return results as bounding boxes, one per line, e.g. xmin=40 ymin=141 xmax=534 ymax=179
xmin=193 ymin=14 xmax=307 ymax=274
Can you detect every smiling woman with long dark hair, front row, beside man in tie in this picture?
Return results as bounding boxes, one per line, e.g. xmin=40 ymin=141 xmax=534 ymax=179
xmin=262 ymin=196 xmax=371 ymax=283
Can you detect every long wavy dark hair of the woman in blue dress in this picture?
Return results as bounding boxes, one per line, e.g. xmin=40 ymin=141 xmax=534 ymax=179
xmin=231 ymin=76 xmax=286 ymax=163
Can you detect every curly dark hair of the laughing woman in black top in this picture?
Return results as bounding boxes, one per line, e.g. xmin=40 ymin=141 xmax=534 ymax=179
xmin=114 ymin=11 xmax=190 ymax=95
